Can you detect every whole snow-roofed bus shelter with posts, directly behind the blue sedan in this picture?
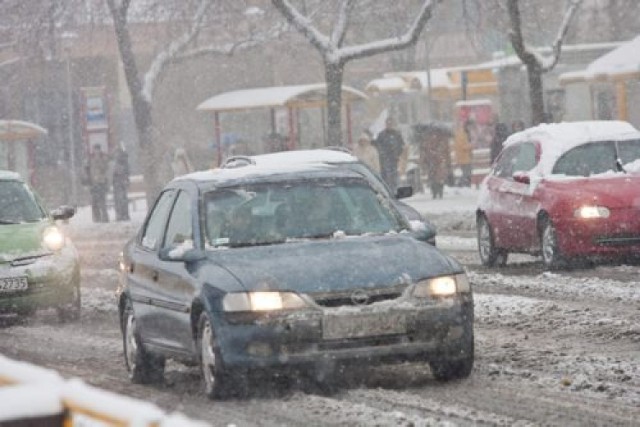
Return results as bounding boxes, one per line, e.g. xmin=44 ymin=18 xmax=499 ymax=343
xmin=197 ymin=83 xmax=367 ymax=163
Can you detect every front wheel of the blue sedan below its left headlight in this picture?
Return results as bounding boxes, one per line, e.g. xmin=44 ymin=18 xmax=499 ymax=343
xmin=198 ymin=313 xmax=232 ymax=399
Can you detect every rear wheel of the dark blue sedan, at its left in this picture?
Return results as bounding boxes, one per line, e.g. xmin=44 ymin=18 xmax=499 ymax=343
xmin=122 ymin=300 xmax=165 ymax=384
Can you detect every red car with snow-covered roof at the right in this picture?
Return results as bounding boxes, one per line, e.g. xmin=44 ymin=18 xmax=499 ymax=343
xmin=476 ymin=121 xmax=640 ymax=268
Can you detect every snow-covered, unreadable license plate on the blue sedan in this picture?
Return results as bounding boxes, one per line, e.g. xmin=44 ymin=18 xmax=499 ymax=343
xmin=322 ymin=313 xmax=407 ymax=340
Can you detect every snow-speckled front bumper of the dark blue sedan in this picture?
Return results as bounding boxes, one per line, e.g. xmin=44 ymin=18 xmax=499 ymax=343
xmin=216 ymin=295 xmax=473 ymax=368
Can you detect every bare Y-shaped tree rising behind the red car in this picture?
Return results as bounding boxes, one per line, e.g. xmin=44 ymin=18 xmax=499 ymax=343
xmin=507 ymin=0 xmax=582 ymax=125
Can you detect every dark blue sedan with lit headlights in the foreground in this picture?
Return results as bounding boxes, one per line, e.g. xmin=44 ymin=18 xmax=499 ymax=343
xmin=118 ymin=160 xmax=474 ymax=397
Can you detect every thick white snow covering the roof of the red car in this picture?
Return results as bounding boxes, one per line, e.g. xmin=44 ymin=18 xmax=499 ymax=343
xmin=504 ymin=120 xmax=640 ymax=175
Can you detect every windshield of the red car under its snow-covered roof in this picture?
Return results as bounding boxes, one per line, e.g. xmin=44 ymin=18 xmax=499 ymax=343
xmin=553 ymin=139 xmax=640 ymax=176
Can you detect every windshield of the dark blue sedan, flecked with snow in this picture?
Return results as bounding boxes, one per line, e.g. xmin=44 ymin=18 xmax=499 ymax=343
xmin=204 ymin=180 xmax=406 ymax=248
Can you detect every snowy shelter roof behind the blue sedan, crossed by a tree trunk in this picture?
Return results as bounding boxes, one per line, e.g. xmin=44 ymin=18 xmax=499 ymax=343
xmin=197 ymin=83 xmax=367 ymax=112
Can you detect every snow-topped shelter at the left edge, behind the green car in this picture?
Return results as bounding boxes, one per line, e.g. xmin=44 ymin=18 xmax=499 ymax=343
xmin=0 ymin=120 xmax=47 ymax=182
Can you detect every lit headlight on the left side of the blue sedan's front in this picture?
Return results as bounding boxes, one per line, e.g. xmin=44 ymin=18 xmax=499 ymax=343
xmin=222 ymin=292 xmax=307 ymax=312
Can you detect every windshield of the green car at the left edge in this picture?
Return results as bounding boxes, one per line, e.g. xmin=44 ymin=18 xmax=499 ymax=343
xmin=0 ymin=181 xmax=45 ymax=225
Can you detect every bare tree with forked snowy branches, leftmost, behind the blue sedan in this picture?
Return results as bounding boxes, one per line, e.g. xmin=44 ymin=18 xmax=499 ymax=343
xmin=107 ymin=0 xmax=283 ymax=203
